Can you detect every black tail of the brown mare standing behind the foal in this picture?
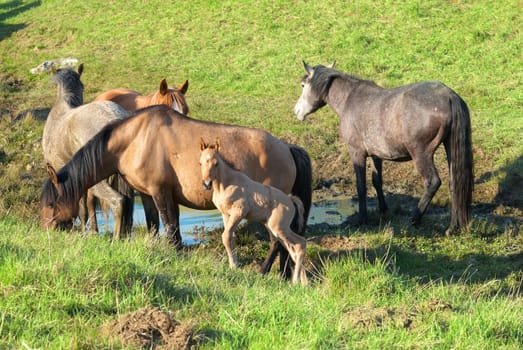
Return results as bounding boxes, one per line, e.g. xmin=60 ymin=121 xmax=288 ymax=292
xmin=289 ymin=145 xmax=312 ymax=235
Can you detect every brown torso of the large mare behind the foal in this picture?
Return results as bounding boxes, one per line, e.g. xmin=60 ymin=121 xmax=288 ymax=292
xmin=108 ymin=105 xmax=296 ymax=209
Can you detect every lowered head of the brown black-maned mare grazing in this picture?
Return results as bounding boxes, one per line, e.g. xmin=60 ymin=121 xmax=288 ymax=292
xmin=40 ymin=165 xmax=78 ymax=229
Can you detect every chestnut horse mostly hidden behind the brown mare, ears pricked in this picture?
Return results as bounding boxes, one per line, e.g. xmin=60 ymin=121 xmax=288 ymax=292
xmin=94 ymin=79 xmax=189 ymax=114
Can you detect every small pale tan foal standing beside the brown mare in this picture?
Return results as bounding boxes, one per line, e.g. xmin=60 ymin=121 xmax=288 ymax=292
xmin=200 ymin=139 xmax=307 ymax=285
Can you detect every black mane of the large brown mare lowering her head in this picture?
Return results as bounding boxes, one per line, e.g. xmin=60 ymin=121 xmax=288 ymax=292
xmin=41 ymin=120 xmax=125 ymax=206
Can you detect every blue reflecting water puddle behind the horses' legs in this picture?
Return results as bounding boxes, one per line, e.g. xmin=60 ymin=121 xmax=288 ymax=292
xmin=97 ymin=198 xmax=358 ymax=244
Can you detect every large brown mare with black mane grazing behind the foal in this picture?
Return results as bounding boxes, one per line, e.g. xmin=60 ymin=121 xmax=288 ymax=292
xmin=40 ymin=105 xmax=312 ymax=275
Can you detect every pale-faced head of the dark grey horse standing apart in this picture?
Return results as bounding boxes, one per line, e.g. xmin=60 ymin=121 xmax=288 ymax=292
xmin=294 ymin=62 xmax=336 ymax=120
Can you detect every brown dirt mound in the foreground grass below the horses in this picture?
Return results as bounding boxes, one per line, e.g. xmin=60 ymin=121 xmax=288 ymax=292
xmin=102 ymin=307 xmax=196 ymax=349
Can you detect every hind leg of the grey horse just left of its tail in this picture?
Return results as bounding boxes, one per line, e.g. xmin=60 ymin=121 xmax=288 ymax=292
xmin=412 ymin=154 xmax=441 ymax=225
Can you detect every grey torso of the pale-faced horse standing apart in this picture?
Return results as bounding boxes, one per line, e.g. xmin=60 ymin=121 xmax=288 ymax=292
xmin=340 ymin=81 xmax=453 ymax=161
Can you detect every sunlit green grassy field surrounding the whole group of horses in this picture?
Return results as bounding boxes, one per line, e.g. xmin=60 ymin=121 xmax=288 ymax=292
xmin=0 ymin=0 xmax=523 ymax=349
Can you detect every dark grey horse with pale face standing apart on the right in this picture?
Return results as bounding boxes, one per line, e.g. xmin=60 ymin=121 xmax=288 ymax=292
xmin=294 ymin=62 xmax=474 ymax=235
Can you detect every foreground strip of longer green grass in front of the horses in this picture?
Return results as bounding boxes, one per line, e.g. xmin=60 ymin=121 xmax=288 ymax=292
xmin=0 ymin=218 xmax=523 ymax=349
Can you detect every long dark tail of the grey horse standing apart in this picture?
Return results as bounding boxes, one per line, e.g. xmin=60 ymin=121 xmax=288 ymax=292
xmin=449 ymin=93 xmax=474 ymax=230
